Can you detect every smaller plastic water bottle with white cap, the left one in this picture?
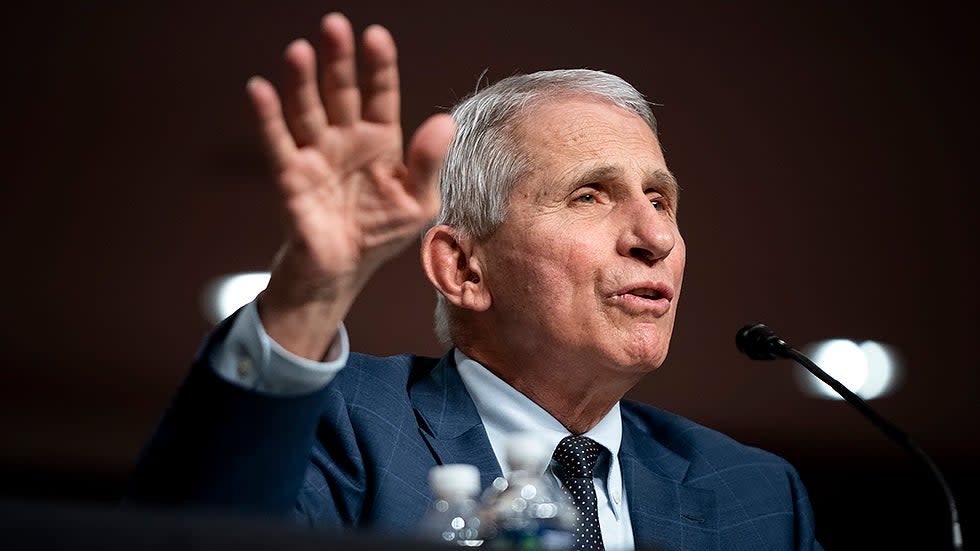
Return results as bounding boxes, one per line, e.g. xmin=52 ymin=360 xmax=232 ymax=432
xmin=420 ymin=464 xmax=483 ymax=547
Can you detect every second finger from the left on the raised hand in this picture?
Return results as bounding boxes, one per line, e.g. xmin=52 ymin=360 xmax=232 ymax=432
xmin=283 ymin=40 xmax=327 ymax=147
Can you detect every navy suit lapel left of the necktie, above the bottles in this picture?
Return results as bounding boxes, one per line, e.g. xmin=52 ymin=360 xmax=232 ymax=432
xmin=409 ymin=350 xmax=503 ymax=488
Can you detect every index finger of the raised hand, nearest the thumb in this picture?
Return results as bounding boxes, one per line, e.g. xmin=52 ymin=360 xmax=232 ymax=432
xmin=361 ymin=25 xmax=401 ymax=124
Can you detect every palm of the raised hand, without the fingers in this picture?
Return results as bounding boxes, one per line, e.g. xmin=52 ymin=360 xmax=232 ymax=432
xmin=279 ymin=121 xmax=428 ymax=284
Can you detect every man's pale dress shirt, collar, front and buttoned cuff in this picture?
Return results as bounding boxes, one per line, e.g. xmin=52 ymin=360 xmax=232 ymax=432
xmin=212 ymin=301 xmax=634 ymax=551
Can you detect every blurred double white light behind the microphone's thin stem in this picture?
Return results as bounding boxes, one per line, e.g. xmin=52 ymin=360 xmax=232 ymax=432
xmin=797 ymin=339 xmax=900 ymax=400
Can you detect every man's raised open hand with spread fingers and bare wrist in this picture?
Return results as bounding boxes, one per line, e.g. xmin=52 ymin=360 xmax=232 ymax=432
xmin=248 ymin=14 xmax=453 ymax=359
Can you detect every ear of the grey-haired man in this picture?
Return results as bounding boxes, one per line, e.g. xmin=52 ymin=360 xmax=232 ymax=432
xmin=422 ymin=224 xmax=491 ymax=312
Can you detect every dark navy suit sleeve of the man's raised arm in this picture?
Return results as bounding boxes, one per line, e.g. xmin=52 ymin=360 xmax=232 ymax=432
xmin=125 ymin=312 xmax=330 ymax=515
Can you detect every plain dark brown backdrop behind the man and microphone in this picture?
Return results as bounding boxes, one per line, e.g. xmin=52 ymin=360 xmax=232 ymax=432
xmin=0 ymin=1 xmax=980 ymax=549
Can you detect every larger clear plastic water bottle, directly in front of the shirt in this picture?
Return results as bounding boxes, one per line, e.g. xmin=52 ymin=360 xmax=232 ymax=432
xmin=481 ymin=434 xmax=576 ymax=551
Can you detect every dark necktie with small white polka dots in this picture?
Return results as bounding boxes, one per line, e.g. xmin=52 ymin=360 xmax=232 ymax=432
xmin=552 ymin=436 xmax=605 ymax=551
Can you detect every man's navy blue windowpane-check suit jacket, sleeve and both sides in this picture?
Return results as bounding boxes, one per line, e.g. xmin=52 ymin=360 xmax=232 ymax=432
xmin=129 ymin=316 xmax=820 ymax=551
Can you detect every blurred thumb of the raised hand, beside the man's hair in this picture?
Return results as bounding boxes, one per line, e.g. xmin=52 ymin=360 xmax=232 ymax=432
xmin=407 ymin=114 xmax=456 ymax=216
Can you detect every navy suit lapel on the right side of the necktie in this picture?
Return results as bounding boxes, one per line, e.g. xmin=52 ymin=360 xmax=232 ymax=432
xmin=620 ymin=412 xmax=718 ymax=551
